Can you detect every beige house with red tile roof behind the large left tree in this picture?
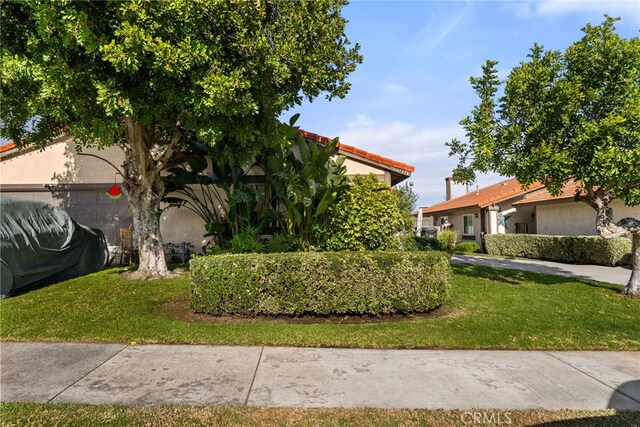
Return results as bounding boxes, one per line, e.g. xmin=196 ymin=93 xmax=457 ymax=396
xmin=0 ymin=130 xmax=415 ymax=248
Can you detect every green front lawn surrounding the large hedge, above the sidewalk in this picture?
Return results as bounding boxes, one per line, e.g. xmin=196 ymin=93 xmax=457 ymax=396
xmin=0 ymin=264 xmax=640 ymax=350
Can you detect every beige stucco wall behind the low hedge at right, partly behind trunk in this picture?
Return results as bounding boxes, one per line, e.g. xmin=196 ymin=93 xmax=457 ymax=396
xmin=536 ymin=200 xmax=640 ymax=236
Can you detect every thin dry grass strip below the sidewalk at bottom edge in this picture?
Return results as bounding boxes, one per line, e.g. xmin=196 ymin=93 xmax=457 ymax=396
xmin=0 ymin=403 xmax=640 ymax=427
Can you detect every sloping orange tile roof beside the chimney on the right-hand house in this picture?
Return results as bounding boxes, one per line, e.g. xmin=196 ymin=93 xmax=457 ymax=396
xmin=416 ymin=178 xmax=543 ymax=215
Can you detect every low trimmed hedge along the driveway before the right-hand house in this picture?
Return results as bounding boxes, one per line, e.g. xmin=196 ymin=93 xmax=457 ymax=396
xmin=484 ymin=234 xmax=631 ymax=266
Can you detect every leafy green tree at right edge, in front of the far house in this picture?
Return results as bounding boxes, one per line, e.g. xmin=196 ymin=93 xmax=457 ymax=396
xmin=448 ymin=16 xmax=640 ymax=295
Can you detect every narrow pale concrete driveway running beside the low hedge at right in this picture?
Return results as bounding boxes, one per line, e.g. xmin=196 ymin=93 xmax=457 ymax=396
xmin=451 ymin=255 xmax=631 ymax=285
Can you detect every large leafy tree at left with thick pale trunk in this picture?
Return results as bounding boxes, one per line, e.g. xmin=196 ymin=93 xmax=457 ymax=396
xmin=0 ymin=0 xmax=361 ymax=277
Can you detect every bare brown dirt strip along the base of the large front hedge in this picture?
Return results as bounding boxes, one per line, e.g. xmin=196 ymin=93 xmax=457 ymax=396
xmin=159 ymin=295 xmax=465 ymax=324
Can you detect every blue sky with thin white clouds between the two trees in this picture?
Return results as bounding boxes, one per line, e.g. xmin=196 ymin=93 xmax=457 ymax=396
xmin=283 ymin=0 xmax=640 ymax=206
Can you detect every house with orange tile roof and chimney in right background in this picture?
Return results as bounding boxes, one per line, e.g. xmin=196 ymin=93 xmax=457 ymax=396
xmin=412 ymin=178 xmax=640 ymax=244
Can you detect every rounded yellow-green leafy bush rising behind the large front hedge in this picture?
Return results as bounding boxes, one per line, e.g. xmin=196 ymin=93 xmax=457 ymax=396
xmin=321 ymin=174 xmax=406 ymax=251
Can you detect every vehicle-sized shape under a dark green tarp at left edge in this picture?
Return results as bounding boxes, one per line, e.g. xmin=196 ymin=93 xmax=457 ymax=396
xmin=0 ymin=194 xmax=109 ymax=297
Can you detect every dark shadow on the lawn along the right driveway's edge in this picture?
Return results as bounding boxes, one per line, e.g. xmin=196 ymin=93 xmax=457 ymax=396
xmin=451 ymin=263 xmax=622 ymax=294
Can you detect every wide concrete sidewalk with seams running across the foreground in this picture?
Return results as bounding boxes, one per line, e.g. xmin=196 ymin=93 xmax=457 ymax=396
xmin=0 ymin=342 xmax=640 ymax=410
